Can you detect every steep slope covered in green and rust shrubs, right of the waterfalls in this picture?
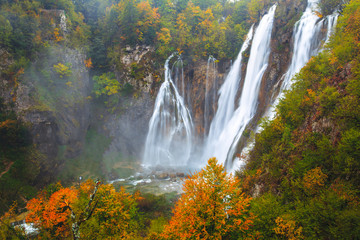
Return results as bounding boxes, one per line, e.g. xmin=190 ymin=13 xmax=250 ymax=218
xmin=239 ymin=0 xmax=360 ymax=239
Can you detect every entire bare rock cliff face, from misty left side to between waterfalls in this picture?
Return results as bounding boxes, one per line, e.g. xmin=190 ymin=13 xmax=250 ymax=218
xmin=0 ymin=0 xmax=316 ymax=179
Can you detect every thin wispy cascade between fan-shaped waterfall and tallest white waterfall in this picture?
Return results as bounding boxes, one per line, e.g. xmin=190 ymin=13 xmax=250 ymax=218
xmin=204 ymin=56 xmax=217 ymax=135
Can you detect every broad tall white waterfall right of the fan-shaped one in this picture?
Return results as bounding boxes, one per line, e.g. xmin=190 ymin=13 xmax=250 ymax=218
xmin=204 ymin=5 xmax=276 ymax=167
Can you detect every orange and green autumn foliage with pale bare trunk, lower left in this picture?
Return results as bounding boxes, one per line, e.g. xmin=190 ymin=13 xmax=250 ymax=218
xmin=26 ymin=180 xmax=138 ymax=239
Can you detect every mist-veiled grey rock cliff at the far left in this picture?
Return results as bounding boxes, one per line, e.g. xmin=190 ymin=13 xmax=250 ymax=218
xmin=1 ymin=46 xmax=90 ymax=180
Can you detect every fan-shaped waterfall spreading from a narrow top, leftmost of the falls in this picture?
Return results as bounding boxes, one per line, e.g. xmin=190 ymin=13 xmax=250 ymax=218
xmin=143 ymin=54 xmax=193 ymax=167
